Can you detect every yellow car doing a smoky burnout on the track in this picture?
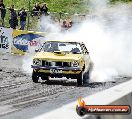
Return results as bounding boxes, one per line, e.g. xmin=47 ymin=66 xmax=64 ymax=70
xmin=31 ymin=41 xmax=92 ymax=85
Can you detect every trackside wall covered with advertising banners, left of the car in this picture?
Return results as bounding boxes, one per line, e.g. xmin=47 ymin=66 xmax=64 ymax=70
xmin=0 ymin=27 xmax=46 ymax=55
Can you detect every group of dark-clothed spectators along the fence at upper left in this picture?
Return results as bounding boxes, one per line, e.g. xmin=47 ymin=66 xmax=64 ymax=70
xmin=0 ymin=0 xmax=48 ymax=30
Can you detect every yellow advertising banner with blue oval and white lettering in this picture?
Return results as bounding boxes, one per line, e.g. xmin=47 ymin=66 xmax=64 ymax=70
xmin=12 ymin=30 xmax=46 ymax=55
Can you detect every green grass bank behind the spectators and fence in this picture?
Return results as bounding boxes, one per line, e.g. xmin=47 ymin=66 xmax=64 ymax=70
xmin=1 ymin=0 xmax=132 ymax=28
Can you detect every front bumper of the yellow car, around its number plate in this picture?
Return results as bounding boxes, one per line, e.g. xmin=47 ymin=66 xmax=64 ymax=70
xmin=31 ymin=65 xmax=81 ymax=75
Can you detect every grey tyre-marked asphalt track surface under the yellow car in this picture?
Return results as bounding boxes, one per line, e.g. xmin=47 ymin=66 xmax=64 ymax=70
xmin=0 ymin=54 xmax=131 ymax=119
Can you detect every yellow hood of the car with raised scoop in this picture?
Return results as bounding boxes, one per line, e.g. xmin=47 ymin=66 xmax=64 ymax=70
xmin=34 ymin=52 xmax=83 ymax=61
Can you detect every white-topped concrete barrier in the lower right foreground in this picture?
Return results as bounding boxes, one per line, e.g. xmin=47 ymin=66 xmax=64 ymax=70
xmin=33 ymin=80 xmax=132 ymax=119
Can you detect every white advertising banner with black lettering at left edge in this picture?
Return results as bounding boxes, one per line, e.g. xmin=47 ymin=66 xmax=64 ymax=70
xmin=0 ymin=27 xmax=13 ymax=53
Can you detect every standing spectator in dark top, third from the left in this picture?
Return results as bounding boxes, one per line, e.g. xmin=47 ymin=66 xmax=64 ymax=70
xmin=18 ymin=8 xmax=27 ymax=30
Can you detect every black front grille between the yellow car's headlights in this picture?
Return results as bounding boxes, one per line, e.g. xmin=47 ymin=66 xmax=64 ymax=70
xmin=42 ymin=61 xmax=71 ymax=67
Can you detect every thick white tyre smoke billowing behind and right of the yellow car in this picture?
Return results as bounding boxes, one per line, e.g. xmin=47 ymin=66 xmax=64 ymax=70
xmin=22 ymin=0 xmax=132 ymax=82
